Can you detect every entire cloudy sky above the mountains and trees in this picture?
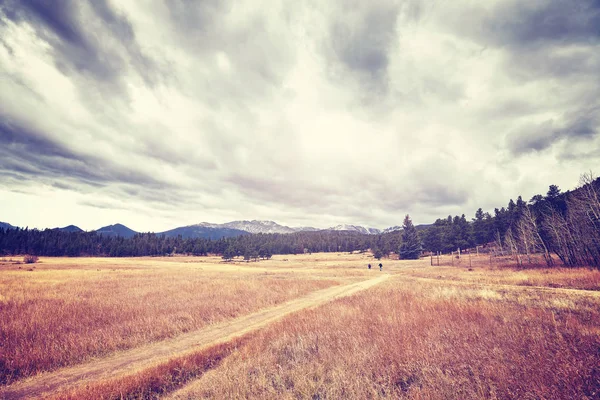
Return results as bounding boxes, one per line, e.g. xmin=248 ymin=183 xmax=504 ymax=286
xmin=0 ymin=0 xmax=600 ymax=231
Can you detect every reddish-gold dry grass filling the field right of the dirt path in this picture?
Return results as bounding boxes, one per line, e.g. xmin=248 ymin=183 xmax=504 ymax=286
xmin=172 ymin=277 xmax=600 ymax=399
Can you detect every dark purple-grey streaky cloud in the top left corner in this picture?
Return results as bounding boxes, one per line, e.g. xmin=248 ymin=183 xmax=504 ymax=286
xmin=0 ymin=0 xmax=159 ymax=91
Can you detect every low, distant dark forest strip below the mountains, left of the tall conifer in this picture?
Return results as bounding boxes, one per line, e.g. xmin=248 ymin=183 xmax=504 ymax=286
xmin=0 ymin=228 xmax=400 ymax=259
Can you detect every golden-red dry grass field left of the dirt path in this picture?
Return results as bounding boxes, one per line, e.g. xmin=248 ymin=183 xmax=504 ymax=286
xmin=0 ymin=258 xmax=337 ymax=384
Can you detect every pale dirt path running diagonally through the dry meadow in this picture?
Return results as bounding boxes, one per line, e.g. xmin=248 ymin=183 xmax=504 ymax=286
xmin=0 ymin=274 xmax=389 ymax=399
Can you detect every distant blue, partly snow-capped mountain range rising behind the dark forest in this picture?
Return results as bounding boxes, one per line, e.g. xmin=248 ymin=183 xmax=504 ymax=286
xmin=0 ymin=220 xmax=402 ymax=239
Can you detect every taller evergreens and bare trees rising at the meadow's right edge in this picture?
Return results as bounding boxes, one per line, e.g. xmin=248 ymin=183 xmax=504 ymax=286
xmin=421 ymin=173 xmax=600 ymax=267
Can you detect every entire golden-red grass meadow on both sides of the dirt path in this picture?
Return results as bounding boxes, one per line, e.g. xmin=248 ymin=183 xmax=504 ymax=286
xmin=0 ymin=253 xmax=600 ymax=399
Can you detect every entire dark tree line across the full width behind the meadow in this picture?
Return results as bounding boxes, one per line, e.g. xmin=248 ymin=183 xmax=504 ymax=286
xmin=0 ymin=173 xmax=600 ymax=267
